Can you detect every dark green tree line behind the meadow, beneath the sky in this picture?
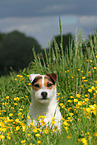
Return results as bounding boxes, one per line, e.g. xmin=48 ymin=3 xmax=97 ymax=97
xmin=0 ymin=31 xmax=93 ymax=76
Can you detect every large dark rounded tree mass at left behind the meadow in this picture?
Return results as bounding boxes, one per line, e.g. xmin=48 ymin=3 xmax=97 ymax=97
xmin=0 ymin=31 xmax=41 ymax=75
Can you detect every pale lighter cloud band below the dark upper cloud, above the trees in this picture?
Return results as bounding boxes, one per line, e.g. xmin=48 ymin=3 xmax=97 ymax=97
xmin=0 ymin=15 xmax=97 ymax=48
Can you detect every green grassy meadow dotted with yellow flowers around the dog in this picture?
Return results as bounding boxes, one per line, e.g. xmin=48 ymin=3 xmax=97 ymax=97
xmin=0 ymin=20 xmax=97 ymax=145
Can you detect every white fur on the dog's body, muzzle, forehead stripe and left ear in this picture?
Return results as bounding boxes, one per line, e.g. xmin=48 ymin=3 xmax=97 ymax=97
xmin=27 ymin=74 xmax=62 ymax=130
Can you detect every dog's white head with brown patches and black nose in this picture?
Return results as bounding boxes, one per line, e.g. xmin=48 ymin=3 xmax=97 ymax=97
xmin=30 ymin=73 xmax=58 ymax=103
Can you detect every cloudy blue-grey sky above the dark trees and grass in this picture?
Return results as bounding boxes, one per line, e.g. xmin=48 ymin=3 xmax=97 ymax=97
xmin=0 ymin=0 xmax=97 ymax=48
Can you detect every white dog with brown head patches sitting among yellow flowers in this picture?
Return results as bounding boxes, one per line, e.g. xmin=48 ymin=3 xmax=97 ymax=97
xmin=27 ymin=73 xmax=62 ymax=130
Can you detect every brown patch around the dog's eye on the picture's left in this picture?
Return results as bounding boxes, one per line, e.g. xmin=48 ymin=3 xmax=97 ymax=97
xmin=32 ymin=76 xmax=42 ymax=91
